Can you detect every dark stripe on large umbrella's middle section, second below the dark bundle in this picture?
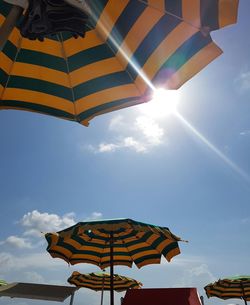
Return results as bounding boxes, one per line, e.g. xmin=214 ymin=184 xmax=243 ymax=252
xmin=68 ymin=44 xmax=114 ymax=72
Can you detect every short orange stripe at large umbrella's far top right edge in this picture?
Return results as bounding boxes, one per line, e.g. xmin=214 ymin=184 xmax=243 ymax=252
xmin=219 ymin=0 xmax=239 ymax=28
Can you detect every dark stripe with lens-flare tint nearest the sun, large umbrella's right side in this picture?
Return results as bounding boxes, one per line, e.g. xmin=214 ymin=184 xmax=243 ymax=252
xmin=152 ymin=32 xmax=212 ymax=85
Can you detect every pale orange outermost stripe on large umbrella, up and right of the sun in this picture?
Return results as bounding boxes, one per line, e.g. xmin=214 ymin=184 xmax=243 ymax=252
xmin=166 ymin=42 xmax=222 ymax=89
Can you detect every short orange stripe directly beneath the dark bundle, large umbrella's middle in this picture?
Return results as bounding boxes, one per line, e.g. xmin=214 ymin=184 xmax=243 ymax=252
xmin=63 ymin=30 xmax=103 ymax=56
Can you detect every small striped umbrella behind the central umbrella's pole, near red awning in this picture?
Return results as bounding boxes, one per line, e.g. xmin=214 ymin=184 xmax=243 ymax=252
xmin=68 ymin=271 xmax=142 ymax=305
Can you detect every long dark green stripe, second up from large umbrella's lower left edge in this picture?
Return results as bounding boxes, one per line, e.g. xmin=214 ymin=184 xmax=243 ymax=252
xmin=8 ymin=76 xmax=72 ymax=100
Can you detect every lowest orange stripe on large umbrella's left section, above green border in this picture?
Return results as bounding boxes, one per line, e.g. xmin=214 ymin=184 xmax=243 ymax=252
xmin=2 ymin=88 xmax=74 ymax=115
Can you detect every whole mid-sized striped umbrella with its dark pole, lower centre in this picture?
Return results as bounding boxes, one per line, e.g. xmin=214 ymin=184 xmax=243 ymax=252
xmin=45 ymin=219 xmax=186 ymax=305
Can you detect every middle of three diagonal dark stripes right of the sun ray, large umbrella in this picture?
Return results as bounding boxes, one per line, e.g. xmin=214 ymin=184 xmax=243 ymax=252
xmin=127 ymin=16 xmax=181 ymax=79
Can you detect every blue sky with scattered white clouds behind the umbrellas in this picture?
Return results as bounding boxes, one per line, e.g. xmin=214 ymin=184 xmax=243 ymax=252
xmin=0 ymin=0 xmax=250 ymax=305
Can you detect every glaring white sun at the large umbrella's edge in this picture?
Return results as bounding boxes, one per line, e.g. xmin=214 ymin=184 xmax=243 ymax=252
xmin=140 ymin=89 xmax=180 ymax=118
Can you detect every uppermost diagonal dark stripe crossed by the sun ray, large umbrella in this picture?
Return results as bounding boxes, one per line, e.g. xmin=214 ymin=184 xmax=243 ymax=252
xmin=107 ymin=0 xmax=147 ymax=53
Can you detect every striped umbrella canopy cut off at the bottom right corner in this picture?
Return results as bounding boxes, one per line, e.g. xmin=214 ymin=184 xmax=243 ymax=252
xmin=204 ymin=275 xmax=250 ymax=305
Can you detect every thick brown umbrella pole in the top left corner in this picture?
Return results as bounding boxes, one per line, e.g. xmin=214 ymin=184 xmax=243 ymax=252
xmin=0 ymin=5 xmax=24 ymax=52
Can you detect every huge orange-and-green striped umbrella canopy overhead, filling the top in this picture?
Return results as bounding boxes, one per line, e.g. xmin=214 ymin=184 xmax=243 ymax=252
xmin=0 ymin=0 xmax=238 ymax=125
